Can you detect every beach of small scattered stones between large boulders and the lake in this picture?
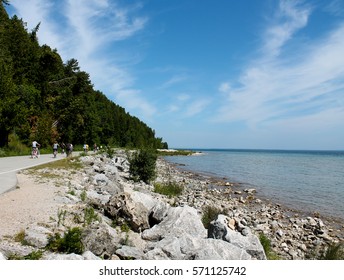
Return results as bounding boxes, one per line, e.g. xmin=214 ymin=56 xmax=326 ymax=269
xmin=159 ymin=156 xmax=344 ymax=259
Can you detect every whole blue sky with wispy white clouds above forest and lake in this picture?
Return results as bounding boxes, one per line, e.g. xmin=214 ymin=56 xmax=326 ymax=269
xmin=7 ymin=0 xmax=344 ymax=150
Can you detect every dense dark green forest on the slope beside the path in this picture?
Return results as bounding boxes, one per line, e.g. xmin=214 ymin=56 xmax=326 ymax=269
xmin=0 ymin=0 xmax=167 ymax=151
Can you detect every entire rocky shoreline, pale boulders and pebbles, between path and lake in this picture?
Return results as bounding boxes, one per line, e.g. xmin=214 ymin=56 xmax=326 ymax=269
xmin=0 ymin=150 xmax=343 ymax=260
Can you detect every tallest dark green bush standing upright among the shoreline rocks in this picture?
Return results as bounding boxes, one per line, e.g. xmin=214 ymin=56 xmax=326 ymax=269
xmin=128 ymin=150 xmax=158 ymax=183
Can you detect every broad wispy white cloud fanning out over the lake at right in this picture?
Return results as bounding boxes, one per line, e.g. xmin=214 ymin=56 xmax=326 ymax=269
xmin=215 ymin=1 xmax=344 ymax=132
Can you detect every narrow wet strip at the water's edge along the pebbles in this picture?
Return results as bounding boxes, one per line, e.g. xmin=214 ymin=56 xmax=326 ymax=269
xmin=162 ymin=157 xmax=344 ymax=233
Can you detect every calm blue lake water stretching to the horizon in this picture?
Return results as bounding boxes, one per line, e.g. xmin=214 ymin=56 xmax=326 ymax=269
xmin=166 ymin=150 xmax=344 ymax=219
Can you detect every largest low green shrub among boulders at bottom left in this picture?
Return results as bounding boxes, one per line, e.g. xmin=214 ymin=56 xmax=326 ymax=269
xmin=47 ymin=227 xmax=84 ymax=254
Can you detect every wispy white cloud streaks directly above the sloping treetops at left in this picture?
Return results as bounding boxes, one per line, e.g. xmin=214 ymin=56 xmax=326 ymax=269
xmin=11 ymin=0 xmax=156 ymax=118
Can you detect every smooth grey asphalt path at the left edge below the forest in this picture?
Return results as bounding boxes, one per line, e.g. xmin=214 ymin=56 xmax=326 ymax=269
xmin=0 ymin=154 xmax=66 ymax=195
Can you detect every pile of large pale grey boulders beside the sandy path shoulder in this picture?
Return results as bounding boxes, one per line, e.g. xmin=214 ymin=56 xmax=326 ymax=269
xmin=0 ymin=151 xmax=266 ymax=260
